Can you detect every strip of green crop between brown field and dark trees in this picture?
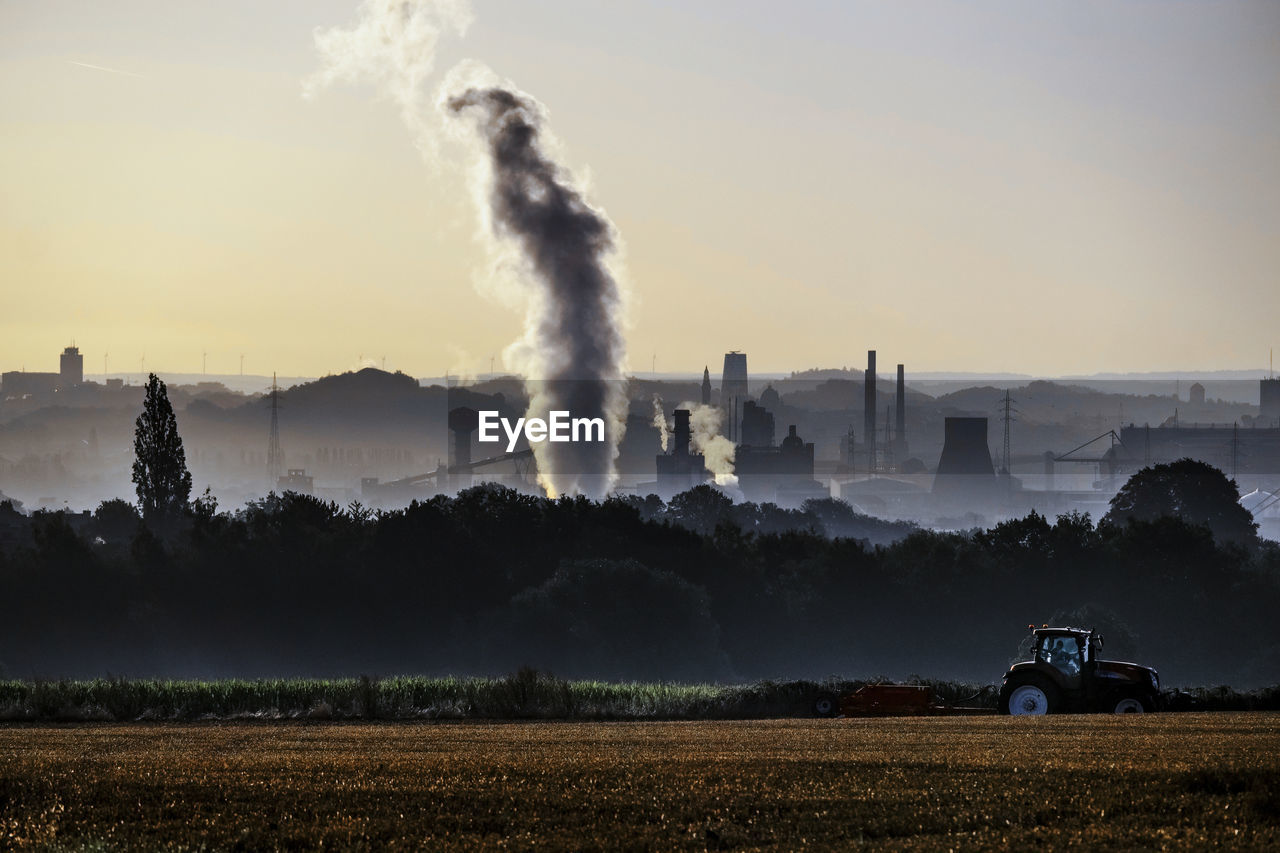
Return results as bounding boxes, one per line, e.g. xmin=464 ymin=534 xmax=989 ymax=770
xmin=0 ymin=670 xmax=1280 ymax=721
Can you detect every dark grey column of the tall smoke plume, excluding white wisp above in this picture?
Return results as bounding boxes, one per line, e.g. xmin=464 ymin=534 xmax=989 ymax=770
xmin=445 ymin=87 xmax=626 ymax=497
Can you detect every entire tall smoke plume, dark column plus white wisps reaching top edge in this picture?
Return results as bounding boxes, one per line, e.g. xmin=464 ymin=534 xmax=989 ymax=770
xmin=303 ymin=0 xmax=626 ymax=497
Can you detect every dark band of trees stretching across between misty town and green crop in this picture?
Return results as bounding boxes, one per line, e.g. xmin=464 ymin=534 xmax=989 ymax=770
xmin=0 ymin=376 xmax=1280 ymax=688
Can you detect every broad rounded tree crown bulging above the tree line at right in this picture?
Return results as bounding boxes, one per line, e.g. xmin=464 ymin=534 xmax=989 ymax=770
xmin=1103 ymin=459 xmax=1258 ymax=544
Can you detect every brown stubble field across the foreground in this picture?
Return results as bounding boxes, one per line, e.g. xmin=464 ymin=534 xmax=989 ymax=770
xmin=0 ymin=713 xmax=1280 ymax=850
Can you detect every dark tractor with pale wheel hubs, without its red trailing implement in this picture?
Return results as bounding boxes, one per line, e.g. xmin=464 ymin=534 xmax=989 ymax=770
xmin=998 ymin=625 xmax=1160 ymax=715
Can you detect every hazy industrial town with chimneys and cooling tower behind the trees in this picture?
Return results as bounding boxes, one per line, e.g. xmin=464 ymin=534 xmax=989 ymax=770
xmin=0 ymin=346 xmax=1280 ymax=538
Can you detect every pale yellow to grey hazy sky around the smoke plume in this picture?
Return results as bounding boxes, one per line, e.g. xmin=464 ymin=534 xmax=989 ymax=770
xmin=0 ymin=0 xmax=1280 ymax=375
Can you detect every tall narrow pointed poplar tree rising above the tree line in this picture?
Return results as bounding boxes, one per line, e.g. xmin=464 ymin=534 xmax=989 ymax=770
xmin=133 ymin=373 xmax=191 ymax=523
